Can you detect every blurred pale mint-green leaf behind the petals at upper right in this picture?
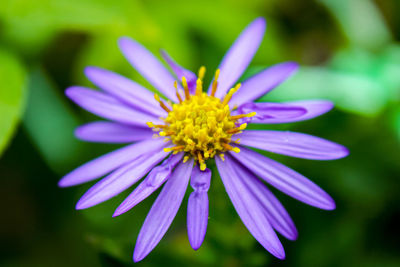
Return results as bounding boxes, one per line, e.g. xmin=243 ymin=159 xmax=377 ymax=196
xmin=260 ymin=67 xmax=387 ymax=115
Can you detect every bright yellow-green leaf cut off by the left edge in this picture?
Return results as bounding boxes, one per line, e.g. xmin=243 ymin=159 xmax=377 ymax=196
xmin=0 ymin=48 xmax=27 ymax=158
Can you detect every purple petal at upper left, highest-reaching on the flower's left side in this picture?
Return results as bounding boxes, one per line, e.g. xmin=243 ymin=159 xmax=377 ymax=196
xmin=118 ymin=37 xmax=178 ymax=102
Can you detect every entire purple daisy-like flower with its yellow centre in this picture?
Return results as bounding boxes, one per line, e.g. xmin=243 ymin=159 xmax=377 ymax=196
xmin=59 ymin=18 xmax=348 ymax=262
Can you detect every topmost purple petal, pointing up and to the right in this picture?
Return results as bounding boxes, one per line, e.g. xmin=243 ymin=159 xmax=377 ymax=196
xmin=208 ymin=18 xmax=266 ymax=98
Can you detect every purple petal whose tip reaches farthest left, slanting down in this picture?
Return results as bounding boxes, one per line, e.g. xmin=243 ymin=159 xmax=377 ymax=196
xmin=58 ymin=139 xmax=168 ymax=187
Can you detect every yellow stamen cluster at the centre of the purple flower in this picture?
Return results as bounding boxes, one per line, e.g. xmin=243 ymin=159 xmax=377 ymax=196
xmin=148 ymin=67 xmax=255 ymax=170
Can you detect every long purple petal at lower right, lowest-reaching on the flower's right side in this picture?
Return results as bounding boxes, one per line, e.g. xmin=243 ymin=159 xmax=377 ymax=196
xmin=215 ymin=154 xmax=285 ymax=259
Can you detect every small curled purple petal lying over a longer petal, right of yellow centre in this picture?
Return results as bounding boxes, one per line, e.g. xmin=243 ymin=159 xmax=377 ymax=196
xmin=234 ymin=102 xmax=307 ymax=124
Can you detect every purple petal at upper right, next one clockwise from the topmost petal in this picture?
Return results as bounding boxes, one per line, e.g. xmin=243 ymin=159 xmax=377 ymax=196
xmin=229 ymin=62 xmax=298 ymax=107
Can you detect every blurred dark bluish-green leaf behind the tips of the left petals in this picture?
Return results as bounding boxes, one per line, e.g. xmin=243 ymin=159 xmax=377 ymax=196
xmin=23 ymin=68 xmax=87 ymax=174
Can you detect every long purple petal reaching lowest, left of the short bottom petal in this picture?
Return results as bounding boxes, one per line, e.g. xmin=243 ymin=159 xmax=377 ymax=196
xmin=133 ymin=160 xmax=193 ymax=262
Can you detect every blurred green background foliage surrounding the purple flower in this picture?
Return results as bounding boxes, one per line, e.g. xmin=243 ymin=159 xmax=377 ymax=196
xmin=0 ymin=0 xmax=400 ymax=266
